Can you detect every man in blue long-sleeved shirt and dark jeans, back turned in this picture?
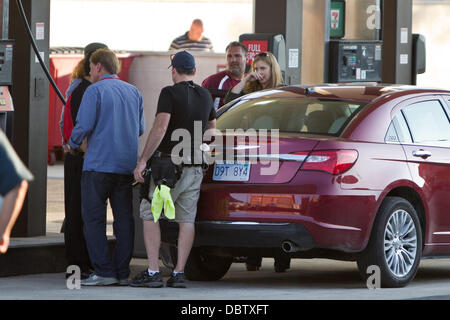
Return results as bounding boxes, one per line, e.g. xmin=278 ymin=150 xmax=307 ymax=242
xmin=69 ymin=49 xmax=145 ymax=285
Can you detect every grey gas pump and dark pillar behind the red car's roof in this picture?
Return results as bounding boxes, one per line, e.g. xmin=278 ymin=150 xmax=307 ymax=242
xmin=326 ymin=0 xmax=426 ymax=84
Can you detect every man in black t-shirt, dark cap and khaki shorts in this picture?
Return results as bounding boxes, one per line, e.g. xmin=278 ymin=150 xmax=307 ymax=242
xmin=130 ymin=51 xmax=216 ymax=288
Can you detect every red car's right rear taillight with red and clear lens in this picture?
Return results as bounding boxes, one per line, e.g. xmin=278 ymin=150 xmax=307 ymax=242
xmin=295 ymin=150 xmax=358 ymax=174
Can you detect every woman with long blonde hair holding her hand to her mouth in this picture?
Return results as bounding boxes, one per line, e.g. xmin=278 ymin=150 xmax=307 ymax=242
xmin=224 ymin=52 xmax=283 ymax=103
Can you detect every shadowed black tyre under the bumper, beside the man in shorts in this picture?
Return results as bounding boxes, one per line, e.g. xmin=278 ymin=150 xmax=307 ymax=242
xmin=184 ymin=248 xmax=233 ymax=281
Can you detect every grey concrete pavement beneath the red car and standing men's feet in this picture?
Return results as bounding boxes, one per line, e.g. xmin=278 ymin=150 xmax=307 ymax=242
xmin=0 ymin=258 xmax=450 ymax=303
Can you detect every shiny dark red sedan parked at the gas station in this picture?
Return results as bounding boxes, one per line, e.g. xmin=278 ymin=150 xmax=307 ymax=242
xmin=161 ymin=84 xmax=450 ymax=287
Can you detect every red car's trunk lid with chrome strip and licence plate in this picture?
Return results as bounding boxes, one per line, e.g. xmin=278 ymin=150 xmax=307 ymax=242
xmin=205 ymin=132 xmax=320 ymax=184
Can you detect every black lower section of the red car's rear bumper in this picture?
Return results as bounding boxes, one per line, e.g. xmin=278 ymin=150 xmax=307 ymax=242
xmin=160 ymin=220 xmax=315 ymax=251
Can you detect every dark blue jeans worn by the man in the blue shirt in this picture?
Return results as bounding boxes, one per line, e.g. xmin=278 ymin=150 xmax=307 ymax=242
xmin=81 ymin=171 xmax=134 ymax=279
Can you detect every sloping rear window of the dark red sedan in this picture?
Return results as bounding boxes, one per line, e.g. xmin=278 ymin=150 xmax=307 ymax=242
xmin=217 ymin=98 xmax=365 ymax=135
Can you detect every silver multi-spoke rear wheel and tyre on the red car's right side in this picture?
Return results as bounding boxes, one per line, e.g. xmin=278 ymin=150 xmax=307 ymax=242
xmin=357 ymin=197 xmax=422 ymax=288
